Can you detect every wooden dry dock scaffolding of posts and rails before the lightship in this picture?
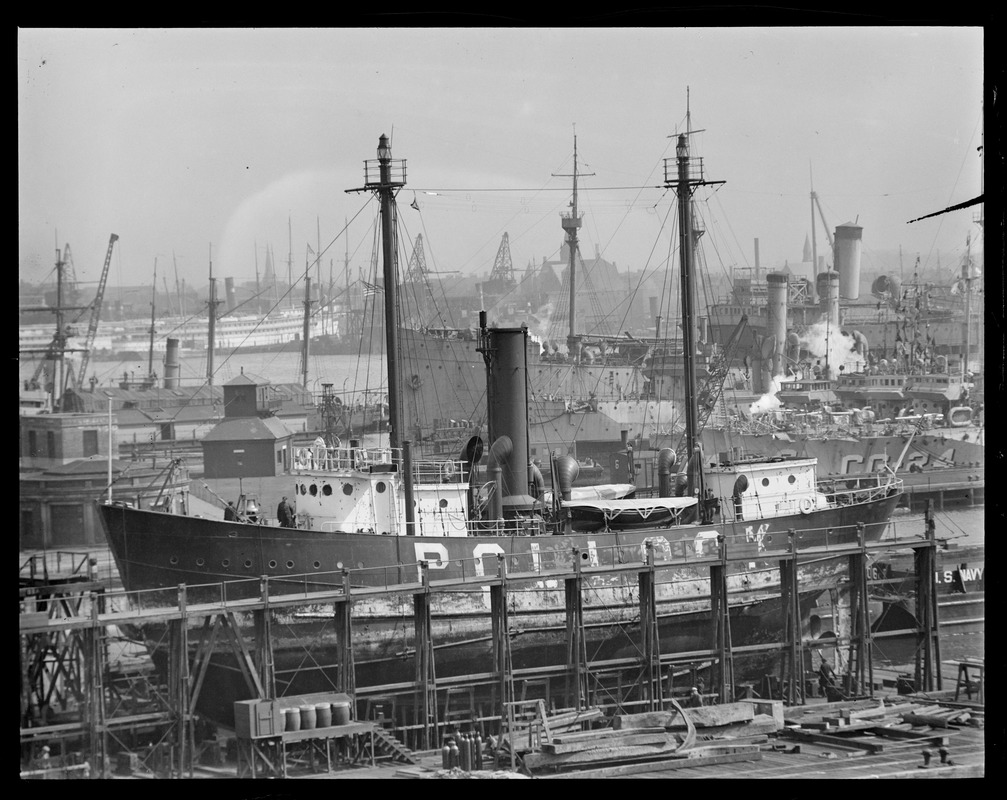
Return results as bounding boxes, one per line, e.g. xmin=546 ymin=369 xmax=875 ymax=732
xmin=19 ymin=507 xmax=966 ymax=777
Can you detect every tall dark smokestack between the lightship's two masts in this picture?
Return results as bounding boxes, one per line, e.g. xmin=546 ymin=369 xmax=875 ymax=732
xmin=487 ymin=327 xmax=535 ymax=517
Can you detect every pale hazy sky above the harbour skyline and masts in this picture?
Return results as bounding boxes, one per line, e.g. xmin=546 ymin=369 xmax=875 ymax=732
xmin=18 ymin=27 xmax=984 ymax=296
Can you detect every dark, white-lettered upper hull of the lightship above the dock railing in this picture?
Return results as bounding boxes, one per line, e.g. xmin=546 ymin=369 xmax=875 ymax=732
xmin=99 ymin=491 xmax=901 ymax=605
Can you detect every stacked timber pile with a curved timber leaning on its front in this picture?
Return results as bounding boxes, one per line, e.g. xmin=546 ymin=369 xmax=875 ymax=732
xmin=512 ymin=700 xmax=782 ymax=778
